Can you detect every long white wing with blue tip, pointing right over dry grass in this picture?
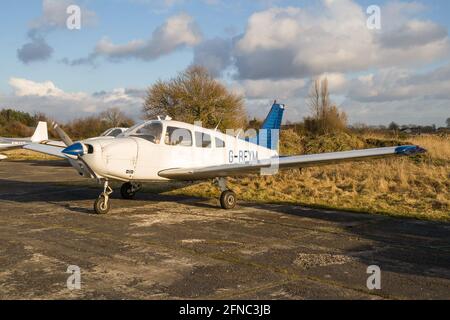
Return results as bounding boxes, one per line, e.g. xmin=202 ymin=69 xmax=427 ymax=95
xmin=158 ymin=146 xmax=425 ymax=181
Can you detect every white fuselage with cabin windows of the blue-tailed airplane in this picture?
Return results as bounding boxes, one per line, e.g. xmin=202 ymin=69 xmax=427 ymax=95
xmin=82 ymin=120 xmax=277 ymax=182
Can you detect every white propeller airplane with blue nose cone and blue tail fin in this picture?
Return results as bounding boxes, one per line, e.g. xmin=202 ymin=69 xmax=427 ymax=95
xmin=25 ymin=103 xmax=426 ymax=214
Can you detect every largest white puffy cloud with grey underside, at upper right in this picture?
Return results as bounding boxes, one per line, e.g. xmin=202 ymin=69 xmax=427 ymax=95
xmin=194 ymin=0 xmax=450 ymax=80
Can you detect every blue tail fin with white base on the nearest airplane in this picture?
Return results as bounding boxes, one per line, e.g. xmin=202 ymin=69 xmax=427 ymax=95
xmin=258 ymin=101 xmax=285 ymax=150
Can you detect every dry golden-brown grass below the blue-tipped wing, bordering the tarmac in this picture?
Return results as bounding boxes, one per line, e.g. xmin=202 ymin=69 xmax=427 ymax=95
xmin=171 ymin=132 xmax=450 ymax=221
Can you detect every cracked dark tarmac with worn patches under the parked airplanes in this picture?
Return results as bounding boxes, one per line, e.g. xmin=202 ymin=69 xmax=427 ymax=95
xmin=0 ymin=161 xmax=450 ymax=299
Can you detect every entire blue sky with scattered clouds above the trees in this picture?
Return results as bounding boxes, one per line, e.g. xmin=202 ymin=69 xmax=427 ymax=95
xmin=0 ymin=0 xmax=450 ymax=126
